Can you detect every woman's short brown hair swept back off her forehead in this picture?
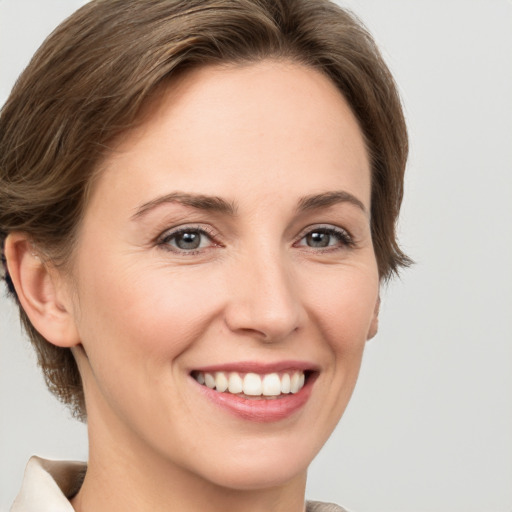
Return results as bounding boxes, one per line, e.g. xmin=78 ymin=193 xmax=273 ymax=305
xmin=0 ymin=0 xmax=409 ymax=418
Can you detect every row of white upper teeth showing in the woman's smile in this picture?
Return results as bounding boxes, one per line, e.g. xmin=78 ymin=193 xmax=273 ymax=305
xmin=193 ymin=371 xmax=306 ymax=397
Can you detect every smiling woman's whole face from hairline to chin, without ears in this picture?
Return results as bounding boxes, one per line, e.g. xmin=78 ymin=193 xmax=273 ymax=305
xmin=65 ymin=61 xmax=379 ymax=489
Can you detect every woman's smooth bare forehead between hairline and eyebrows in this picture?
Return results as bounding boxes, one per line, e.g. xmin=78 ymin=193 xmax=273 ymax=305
xmin=92 ymin=61 xmax=370 ymax=211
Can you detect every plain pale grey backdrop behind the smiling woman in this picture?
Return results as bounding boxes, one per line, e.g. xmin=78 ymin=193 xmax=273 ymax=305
xmin=0 ymin=0 xmax=512 ymax=512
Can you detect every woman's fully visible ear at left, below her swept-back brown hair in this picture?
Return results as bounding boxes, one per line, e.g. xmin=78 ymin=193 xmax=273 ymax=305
xmin=5 ymin=233 xmax=80 ymax=347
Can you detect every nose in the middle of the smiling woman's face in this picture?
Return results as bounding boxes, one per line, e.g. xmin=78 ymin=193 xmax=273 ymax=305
xmin=225 ymin=246 xmax=305 ymax=343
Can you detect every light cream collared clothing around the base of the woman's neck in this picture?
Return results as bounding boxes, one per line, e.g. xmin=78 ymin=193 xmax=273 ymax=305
xmin=11 ymin=457 xmax=347 ymax=512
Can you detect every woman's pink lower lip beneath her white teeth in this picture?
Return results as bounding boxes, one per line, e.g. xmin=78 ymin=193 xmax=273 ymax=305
xmin=194 ymin=375 xmax=316 ymax=423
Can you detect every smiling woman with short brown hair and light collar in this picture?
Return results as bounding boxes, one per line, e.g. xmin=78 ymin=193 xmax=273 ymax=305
xmin=0 ymin=0 xmax=408 ymax=512
